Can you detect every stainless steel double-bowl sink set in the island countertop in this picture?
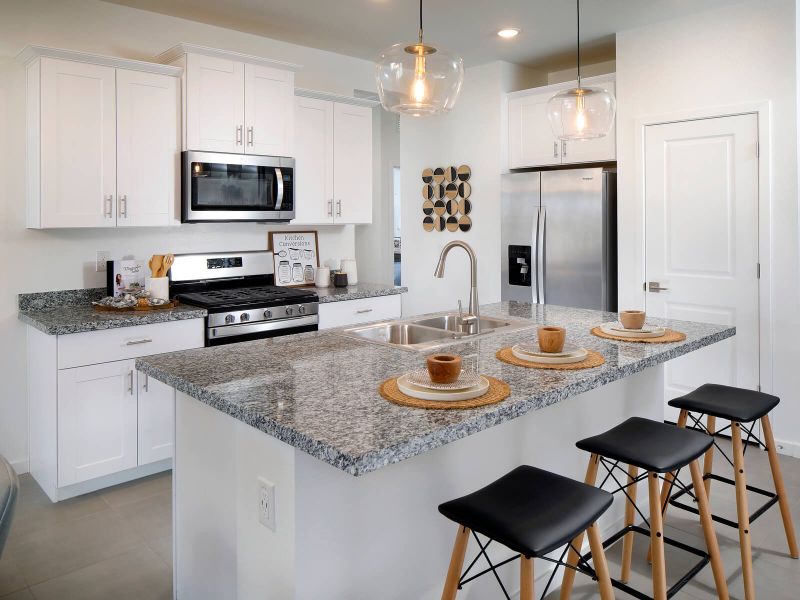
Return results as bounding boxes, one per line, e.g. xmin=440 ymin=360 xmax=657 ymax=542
xmin=341 ymin=314 xmax=536 ymax=350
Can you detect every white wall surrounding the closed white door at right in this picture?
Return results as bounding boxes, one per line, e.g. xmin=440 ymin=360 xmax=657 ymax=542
xmin=616 ymin=0 xmax=800 ymax=455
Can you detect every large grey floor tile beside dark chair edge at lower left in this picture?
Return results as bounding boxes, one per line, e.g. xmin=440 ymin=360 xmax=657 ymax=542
xmin=13 ymin=509 xmax=143 ymax=586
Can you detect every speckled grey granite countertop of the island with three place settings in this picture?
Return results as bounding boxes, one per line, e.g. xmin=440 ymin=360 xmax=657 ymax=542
xmin=136 ymin=302 xmax=736 ymax=475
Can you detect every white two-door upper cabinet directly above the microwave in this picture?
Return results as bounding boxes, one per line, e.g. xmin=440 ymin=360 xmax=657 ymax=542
xmin=157 ymin=44 xmax=300 ymax=156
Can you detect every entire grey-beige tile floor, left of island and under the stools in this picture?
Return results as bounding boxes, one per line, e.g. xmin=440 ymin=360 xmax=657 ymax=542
xmin=0 ymin=442 xmax=800 ymax=600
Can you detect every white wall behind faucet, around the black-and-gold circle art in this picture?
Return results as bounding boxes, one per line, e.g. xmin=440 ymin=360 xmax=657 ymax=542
xmin=400 ymin=62 xmax=546 ymax=315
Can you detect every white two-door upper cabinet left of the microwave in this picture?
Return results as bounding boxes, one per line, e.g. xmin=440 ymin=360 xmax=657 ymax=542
xmin=18 ymin=46 xmax=181 ymax=229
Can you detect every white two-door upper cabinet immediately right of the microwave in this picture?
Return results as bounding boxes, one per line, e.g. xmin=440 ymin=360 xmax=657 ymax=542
xmin=292 ymin=90 xmax=372 ymax=225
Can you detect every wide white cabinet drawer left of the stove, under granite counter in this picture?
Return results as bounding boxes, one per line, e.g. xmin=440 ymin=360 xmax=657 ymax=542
xmin=58 ymin=319 xmax=205 ymax=369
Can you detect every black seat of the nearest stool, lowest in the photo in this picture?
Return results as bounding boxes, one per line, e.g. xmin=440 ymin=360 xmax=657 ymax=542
xmin=439 ymin=466 xmax=613 ymax=557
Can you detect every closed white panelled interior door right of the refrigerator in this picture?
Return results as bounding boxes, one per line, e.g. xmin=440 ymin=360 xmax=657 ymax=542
xmin=644 ymin=114 xmax=759 ymax=420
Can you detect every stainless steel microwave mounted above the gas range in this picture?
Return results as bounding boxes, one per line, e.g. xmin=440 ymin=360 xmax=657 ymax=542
xmin=181 ymin=150 xmax=295 ymax=223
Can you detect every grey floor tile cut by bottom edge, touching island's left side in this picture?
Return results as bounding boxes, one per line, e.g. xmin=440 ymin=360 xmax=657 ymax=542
xmin=32 ymin=544 xmax=172 ymax=600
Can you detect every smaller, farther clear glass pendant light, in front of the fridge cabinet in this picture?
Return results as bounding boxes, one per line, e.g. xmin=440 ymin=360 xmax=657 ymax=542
xmin=547 ymin=0 xmax=617 ymax=140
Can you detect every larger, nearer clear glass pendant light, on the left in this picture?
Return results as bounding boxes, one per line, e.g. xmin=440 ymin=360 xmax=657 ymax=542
xmin=375 ymin=0 xmax=464 ymax=117
